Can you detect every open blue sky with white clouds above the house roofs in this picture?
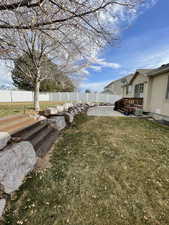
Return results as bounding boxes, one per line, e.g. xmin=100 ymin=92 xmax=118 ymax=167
xmin=81 ymin=0 xmax=169 ymax=91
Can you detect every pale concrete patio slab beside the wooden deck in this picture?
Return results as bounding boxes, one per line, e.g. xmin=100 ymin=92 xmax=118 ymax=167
xmin=87 ymin=106 xmax=124 ymax=117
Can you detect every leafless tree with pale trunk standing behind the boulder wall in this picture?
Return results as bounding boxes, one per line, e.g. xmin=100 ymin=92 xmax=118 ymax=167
xmin=1 ymin=27 xmax=91 ymax=111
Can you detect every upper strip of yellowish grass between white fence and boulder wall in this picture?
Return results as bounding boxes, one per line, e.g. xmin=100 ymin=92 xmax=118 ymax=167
xmin=0 ymin=102 xmax=63 ymax=117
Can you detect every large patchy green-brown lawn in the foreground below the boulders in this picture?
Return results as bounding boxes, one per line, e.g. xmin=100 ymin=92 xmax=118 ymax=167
xmin=2 ymin=116 xmax=169 ymax=225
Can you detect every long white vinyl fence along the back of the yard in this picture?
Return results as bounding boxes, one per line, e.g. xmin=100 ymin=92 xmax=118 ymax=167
xmin=0 ymin=90 xmax=121 ymax=103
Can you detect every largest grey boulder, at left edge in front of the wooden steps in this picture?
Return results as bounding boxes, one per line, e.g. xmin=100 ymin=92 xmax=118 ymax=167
xmin=0 ymin=141 xmax=37 ymax=194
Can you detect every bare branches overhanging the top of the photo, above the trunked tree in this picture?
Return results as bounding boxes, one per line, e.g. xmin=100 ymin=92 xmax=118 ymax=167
xmin=0 ymin=0 xmax=144 ymax=50
